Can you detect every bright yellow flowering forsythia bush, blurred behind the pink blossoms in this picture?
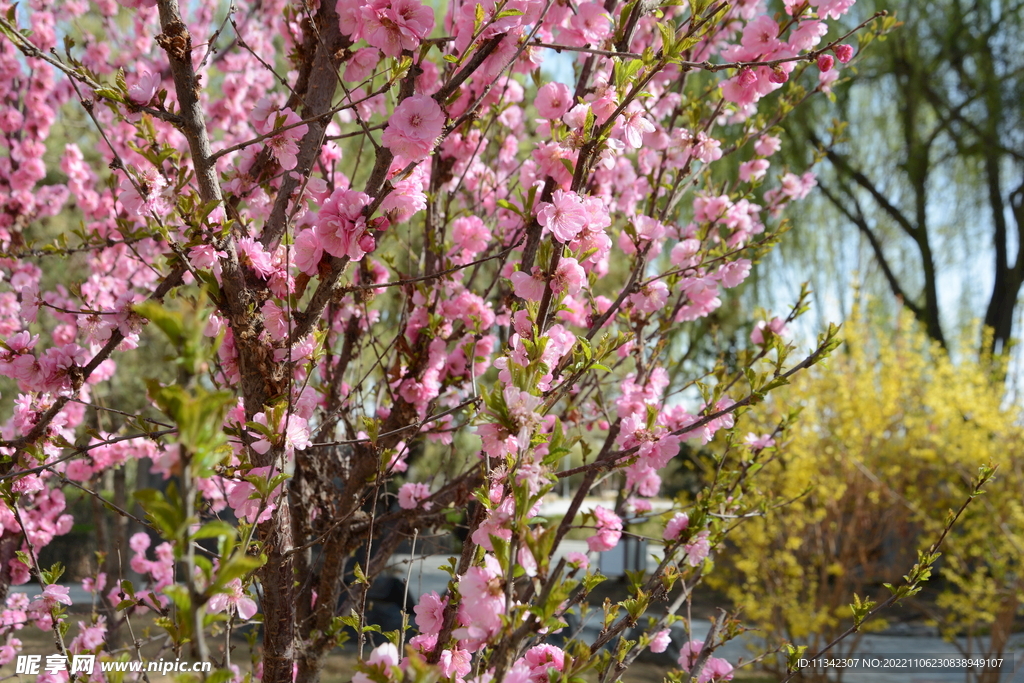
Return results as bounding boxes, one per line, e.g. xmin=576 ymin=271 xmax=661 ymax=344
xmin=709 ymin=317 xmax=1024 ymax=679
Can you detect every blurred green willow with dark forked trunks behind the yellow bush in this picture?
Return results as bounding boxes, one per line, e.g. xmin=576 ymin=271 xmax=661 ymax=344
xmin=774 ymin=0 xmax=1024 ymax=362
